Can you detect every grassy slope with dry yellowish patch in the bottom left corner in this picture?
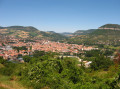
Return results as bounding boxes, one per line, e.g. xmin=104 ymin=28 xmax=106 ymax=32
xmin=0 ymin=57 xmax=26 ymax=89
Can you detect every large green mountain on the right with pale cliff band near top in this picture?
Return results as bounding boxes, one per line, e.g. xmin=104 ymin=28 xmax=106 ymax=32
xmin=68 ymin=24 xmax=120 ymax=45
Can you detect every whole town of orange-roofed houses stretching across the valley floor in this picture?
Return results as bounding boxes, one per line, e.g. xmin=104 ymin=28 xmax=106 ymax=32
xmin=0 ymin=38 xmax=96 ymax=65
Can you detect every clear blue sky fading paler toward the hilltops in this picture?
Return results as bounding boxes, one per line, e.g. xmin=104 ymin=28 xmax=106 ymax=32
xmin=0 ymin=0 xmax=120 ymax=32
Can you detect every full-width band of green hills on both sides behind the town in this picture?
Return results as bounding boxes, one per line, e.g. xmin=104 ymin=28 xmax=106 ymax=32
xmin=0 ymin=24 xmax=120 ymax=46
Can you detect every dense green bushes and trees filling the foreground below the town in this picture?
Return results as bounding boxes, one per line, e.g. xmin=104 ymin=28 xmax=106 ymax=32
xmin=0 ymin=50 xmax=120 ymax=89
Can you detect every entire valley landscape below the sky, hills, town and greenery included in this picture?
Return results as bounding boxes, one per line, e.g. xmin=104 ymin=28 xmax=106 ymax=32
xmin=0 ymin=24 xmax=120 ymax=89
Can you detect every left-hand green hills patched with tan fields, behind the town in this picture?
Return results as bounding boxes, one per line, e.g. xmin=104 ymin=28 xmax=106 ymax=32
xmin=0 ymin=26 xmax=66 ymax=41
